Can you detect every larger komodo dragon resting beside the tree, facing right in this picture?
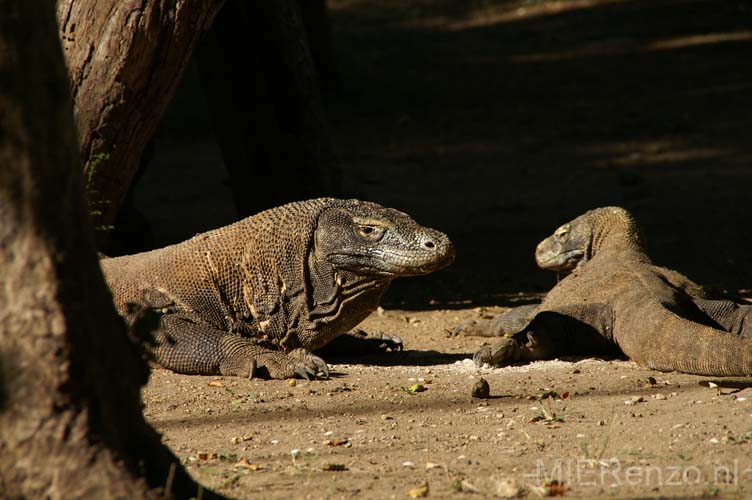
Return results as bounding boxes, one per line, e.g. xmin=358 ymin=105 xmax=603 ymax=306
xmin=101 ymin=198 xmax=454 ymax=378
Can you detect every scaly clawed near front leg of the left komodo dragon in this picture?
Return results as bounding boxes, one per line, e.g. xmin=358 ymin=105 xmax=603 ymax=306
xmin=154 ymin=314 xmax=329 ymax=379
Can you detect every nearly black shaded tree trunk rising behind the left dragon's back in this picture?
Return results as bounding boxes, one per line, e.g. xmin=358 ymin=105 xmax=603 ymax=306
xmin=197 ymin=0 xmax=340 ymax=216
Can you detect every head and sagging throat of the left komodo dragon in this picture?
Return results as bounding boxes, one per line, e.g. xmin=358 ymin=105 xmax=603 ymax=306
xmin=281 ymin=199 xmax=454 ymax=350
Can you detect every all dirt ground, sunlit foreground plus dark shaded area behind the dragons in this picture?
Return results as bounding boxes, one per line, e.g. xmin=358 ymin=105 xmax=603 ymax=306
xmin=136 ymin=0 xmax=752 ymax=499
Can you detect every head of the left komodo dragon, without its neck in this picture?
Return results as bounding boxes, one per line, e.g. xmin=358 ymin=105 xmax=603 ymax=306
xmin=315 ymin=200 xmax=455 ymax=279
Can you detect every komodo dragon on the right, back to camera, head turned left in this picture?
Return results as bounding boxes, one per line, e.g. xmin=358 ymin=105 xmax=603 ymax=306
xmin=454 ymin=207 xmax=752 ymax=376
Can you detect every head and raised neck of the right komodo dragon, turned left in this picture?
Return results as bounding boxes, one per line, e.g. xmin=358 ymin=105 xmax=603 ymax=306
xmin=535 ymin=207 xmax=643 ymax=272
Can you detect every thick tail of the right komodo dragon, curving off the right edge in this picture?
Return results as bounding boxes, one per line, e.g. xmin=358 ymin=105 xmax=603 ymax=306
xmin=619 ymin=304 xmax=752 ymax=377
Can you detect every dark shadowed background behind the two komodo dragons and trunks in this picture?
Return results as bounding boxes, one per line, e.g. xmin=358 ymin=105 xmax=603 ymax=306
xmin=128 ymin=0 xmax=752 ymax=308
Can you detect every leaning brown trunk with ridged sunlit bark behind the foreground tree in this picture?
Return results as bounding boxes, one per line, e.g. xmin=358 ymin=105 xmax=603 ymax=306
xmin=57 ymin=0 xmax=223 ymax=240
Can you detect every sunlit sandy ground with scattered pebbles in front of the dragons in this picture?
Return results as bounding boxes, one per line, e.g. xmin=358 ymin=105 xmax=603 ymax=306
xmin=144 ymin=309 xmax=752 ymax=499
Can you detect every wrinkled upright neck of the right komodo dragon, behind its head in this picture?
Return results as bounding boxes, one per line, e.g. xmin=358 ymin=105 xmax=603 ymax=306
xmin=577 ymin=211 xmax=649 ymax=268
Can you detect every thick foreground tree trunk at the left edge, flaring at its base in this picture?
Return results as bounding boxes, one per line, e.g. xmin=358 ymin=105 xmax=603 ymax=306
xmin=0 ymin=0 xmax=223 ymax=498
